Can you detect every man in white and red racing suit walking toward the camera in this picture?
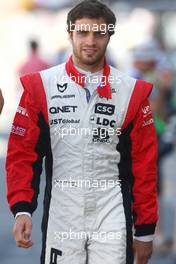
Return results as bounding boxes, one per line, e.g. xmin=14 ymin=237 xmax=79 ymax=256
xmin=6 ymin=0 xmax=157 ymax=264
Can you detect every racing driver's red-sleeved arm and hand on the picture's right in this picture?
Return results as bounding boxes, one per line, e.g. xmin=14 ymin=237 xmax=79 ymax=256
xmin=130 ymin=100 xmax=158 ymax=264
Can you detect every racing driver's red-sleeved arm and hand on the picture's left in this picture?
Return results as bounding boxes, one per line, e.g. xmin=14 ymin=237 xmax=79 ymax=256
xmin=6 ymin=73 xmax=46 ymax=248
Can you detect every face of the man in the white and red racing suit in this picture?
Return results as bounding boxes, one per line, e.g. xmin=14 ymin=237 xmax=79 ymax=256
xmin=70 ymin=18 xmax=110 ymax=65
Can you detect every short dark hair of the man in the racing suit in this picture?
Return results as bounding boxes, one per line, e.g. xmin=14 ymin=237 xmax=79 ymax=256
xmin=67 ymin=0 xmax=116 ymax=36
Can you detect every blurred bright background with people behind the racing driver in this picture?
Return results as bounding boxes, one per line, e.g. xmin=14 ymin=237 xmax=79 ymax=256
xmin=0 ymin=0 xmax=176 ymax=264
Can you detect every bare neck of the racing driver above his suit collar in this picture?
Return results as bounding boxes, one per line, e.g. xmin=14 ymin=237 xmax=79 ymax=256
xmin=72 ymin=55 xmax=104 ymax=73
